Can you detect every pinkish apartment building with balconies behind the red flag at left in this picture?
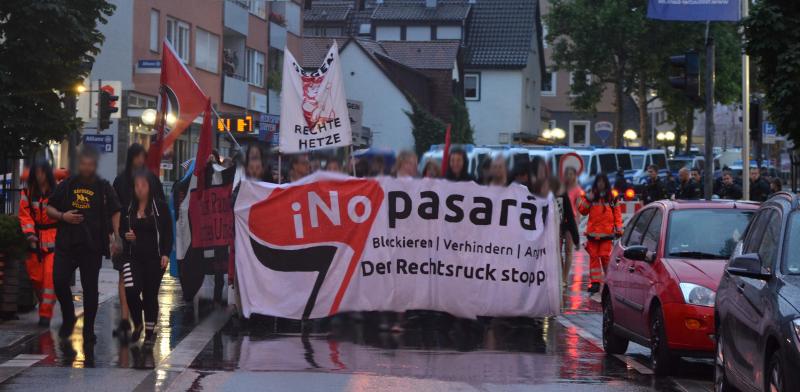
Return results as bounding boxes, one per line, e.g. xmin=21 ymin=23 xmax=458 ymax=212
xmin=61 ymin=0 xmax=303 ymax=184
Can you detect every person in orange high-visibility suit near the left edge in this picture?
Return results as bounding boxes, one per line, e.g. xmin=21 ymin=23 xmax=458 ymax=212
xmin=19 ymin=162 xmax=57 ymax=327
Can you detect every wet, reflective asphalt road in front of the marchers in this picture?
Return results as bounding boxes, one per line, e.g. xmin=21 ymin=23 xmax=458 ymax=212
xmin=0 ymin=253 xmax=713 ymax=392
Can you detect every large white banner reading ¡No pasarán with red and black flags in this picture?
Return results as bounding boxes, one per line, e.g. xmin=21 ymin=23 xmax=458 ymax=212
xmin=234 ymin=172 xmax=561 ymax=319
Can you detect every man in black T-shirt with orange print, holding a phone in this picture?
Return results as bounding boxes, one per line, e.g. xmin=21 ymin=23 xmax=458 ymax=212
xmin=47 ymin=146 xmax=120 ymax=343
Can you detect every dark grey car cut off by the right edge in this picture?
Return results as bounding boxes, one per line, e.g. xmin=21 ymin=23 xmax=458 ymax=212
xmin=714 ymin=193 xmax=800 ymax=392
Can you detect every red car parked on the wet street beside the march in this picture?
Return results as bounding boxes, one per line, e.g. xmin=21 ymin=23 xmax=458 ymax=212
xmin=602 ymin=200 xmax=758 ymax=375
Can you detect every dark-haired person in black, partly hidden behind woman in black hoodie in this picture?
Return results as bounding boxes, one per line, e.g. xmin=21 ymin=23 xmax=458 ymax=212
xmin=112 ymin=143 xmax=166 ymax=339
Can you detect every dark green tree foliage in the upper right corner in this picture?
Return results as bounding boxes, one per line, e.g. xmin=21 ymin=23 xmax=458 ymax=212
xmin=744 ymin=0 xmax=800 ymax=145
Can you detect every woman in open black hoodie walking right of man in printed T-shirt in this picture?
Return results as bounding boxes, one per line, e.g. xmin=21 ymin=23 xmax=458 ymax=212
xmin=120 ymin=170 xmax=172 ymax=344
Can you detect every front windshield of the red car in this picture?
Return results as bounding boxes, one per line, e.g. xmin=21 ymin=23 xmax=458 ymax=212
xmin=664 ymin=209 xmax=753 ymax=259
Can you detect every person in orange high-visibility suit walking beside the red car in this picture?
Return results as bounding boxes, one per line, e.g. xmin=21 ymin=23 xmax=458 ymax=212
xmin=577 ymin=173 xmax=622 ymax=293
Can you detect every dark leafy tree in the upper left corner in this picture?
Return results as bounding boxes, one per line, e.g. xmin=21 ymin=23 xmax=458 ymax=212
xmin=0 ymin=0 xmax=114 ymax=158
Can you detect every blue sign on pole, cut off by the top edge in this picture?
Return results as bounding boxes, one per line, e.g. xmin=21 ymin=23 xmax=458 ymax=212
xmin=647 ymin=0 xmax=742 ymax=22
